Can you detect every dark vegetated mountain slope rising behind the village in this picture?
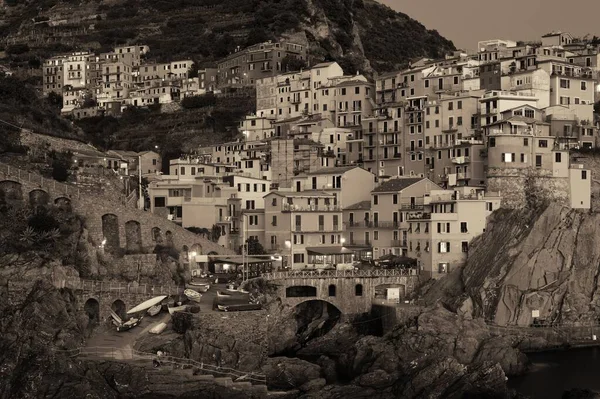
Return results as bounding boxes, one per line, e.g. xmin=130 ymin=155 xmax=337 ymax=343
xmin=0 ymin=0 xmax=454 ymax=73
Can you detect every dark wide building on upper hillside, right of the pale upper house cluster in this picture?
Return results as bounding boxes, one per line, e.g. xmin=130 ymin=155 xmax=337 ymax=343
xmin=217 ymin=40 xmax=306 ymax=88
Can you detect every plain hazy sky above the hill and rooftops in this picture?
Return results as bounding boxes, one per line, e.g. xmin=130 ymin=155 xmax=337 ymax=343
xmin=378 ymin=0 xmax=600 ymax=50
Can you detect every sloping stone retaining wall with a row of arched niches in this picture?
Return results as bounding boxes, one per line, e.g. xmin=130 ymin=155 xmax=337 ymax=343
xmin=0 ymin=163 xmax=233 ymax=255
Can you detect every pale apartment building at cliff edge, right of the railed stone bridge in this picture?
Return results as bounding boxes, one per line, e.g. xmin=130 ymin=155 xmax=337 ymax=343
xmin=406 ymin=187 xmax=501 ymax=278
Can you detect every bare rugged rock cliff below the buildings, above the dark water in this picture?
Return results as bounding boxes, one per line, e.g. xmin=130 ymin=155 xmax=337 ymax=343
xmin=428 ymin=204 xmax=600 ymax=326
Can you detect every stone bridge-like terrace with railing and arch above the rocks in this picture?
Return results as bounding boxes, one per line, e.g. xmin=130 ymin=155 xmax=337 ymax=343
xmin=262 ymin=270 xmax=419 ymax=315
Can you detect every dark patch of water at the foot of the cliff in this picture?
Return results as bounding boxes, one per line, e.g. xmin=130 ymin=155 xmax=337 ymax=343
xmin=508 ymin=348 xmax=600 ymax=399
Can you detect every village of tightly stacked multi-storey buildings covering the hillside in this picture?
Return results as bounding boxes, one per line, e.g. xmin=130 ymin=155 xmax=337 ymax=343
xmin=14 ymin=32 xmax=600 ymax=277
